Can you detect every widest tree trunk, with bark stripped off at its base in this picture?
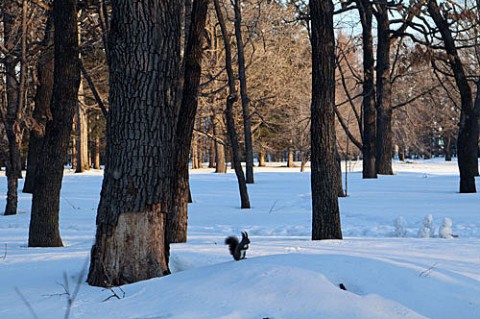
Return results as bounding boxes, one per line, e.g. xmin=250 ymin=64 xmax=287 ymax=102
xmin=87 ymin=0 xmax=182 ymax=287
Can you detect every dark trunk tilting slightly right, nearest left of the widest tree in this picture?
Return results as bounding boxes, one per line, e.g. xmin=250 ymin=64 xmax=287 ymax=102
xmin=28 ymin=0 xmax=80 ymax=247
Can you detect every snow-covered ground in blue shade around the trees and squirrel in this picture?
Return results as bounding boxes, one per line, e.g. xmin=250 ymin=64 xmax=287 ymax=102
xmin=0 ymin=160 xmax=480 ymax=319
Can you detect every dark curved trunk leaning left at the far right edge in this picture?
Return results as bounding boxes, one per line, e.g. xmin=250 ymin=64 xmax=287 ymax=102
xmin=427 ymin=0 xmax=480 ymax=193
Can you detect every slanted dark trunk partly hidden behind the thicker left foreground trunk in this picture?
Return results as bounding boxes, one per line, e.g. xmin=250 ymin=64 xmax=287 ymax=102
xmin=23 ymin=14 xmax=54 ymax=194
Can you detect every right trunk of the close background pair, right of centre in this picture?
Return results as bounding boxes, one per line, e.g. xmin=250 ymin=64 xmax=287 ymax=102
xmin=375 ymin=0 xmax=393 ymax=175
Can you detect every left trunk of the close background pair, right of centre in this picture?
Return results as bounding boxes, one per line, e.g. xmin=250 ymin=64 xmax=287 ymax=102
xmin=356 ymin=0 xmax=377 ymax=178
